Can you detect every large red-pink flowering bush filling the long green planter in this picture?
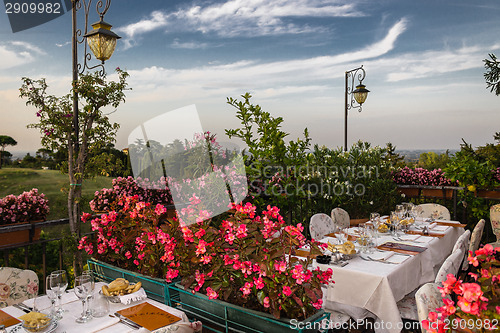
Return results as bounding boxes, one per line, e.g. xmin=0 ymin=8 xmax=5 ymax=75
xmin=79 ymin=196 xmax=332 ymax=319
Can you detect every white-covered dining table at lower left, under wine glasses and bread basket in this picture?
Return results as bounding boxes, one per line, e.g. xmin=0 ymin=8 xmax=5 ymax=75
xmin=0 ymin=282 xmax=189 ymax=333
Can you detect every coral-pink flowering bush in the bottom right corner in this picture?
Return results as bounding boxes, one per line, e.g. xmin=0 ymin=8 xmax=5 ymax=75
xmin=422 ymin=244 xmax=500 ymax=333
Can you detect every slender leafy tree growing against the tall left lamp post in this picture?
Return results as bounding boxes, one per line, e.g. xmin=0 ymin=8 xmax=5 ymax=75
xmin=19 ymin=68 xmax=129 ymax=252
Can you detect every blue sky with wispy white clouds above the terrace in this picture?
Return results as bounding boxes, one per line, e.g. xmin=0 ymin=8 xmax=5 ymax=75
xmin=0 ymin=0 xmax=500 ymax=151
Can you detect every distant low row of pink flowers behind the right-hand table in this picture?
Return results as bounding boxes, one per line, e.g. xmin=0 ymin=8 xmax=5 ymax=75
xmin=392 ymin=167 xmax=458 ymax=186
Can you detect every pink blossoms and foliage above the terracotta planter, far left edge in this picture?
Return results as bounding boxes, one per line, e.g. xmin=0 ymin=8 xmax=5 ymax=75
xmin=0 ymin=188 xmax=50 ymax=225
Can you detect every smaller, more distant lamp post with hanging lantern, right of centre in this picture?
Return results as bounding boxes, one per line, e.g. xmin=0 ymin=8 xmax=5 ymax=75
xmin=344 ymin=65 xmax=370 ymax=151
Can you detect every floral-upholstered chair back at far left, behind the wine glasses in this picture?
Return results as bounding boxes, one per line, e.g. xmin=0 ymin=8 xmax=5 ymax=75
xmin=0 ymin=267 xmax=38 ymax=308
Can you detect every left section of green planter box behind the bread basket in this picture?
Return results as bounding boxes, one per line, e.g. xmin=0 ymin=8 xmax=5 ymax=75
xmin=87 ymin=258 xmax=178 ymax=306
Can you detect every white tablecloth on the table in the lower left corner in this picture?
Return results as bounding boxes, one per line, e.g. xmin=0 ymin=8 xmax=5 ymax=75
xmin=2 ymin=282 xmax=189 ymax=333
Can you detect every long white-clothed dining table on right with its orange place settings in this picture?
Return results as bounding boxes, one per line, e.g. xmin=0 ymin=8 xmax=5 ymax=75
xmin=313 ymin=219 xmax=465 ymax=333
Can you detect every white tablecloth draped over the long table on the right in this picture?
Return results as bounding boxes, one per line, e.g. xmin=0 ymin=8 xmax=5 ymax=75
xmin=315 ymin=220 xmax=464 ymax=333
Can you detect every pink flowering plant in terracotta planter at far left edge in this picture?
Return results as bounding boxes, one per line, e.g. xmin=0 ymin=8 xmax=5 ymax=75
xmin=0 ymin=188 xmax=50 ymax=246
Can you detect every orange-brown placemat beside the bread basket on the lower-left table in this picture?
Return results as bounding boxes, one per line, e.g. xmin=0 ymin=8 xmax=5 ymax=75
xmin=117 ymin=302 xmax=181 ymax=331
